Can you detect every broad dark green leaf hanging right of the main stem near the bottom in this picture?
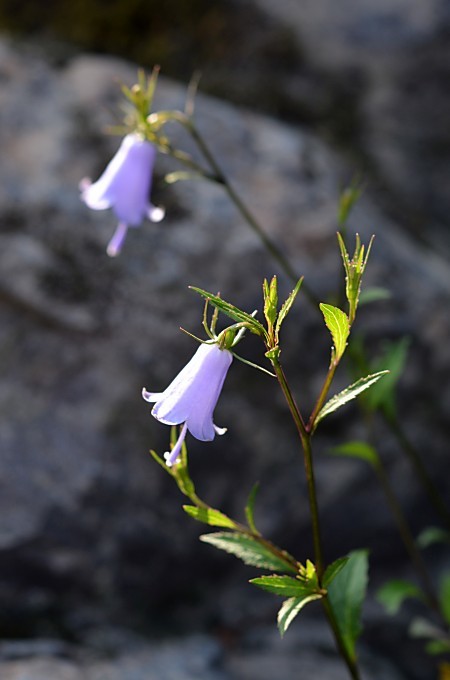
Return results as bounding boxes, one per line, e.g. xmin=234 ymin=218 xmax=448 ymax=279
xmin=328 ymin=550 xmax=368 ymax=660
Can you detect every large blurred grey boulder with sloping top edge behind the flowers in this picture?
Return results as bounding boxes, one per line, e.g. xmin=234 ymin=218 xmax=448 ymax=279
xmin=0 ymin=34 xmax=450 ymax=680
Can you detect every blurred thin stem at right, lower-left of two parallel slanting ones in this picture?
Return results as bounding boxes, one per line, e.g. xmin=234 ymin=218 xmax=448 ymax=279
xmin=374 ymin=457 xmax=442 ymax=618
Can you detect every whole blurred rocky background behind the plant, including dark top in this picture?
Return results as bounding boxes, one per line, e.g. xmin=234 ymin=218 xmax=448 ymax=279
xmin=0 ymin=0 xmax=450 ymax=680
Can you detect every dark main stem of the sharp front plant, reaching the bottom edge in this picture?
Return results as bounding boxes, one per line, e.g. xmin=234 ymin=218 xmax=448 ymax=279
xmin=272 ymin=358 xmax=360 ymax=680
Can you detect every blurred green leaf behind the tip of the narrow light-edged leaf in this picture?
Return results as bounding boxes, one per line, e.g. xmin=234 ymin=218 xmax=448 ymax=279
xmin=364 ymin=338 xmax=409 ymax=417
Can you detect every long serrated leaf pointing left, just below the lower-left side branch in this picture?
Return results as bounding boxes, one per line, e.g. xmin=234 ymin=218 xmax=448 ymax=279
xmin=200 ymin=531 xmax=297 ymax=573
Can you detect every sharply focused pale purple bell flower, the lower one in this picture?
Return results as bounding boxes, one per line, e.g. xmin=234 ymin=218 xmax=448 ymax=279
xmin=142 ymin=343 xmax=233 ymax=466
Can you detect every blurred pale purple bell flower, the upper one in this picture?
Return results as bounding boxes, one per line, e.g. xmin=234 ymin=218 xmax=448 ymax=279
xmin=80 ymin=133 xmax=164 ymax=257
